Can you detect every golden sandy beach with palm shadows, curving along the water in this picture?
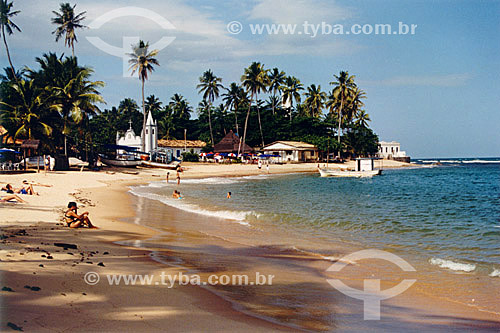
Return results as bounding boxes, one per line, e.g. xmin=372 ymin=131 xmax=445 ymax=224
xmin=0 ymin=161 xmax=500 ymax=332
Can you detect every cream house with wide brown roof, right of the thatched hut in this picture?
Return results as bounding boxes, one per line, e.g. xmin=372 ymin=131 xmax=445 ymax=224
xmin=262 ymin=141 xmax=319 ymax=162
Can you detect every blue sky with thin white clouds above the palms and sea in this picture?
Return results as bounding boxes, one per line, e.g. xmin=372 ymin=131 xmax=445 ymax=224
xmin=0 ymin=0 xmax=500 ymax=157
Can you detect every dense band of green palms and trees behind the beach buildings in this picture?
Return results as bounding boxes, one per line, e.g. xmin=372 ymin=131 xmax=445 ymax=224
xmin=0 ymin=0 xmax=378 ymax=159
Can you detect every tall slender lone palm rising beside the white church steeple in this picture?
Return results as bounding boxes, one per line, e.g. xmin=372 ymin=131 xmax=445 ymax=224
xmin=128 ymin=40 xmax=160 ymax=151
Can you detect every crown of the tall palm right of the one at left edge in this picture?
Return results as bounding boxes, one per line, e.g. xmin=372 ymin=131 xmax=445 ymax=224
xmin=52 ymin=3 xmax=87 ymax=57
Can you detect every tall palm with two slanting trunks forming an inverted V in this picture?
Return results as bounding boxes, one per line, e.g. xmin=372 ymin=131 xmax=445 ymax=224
xmin=238 ymin=61 xmax=268 ymax=155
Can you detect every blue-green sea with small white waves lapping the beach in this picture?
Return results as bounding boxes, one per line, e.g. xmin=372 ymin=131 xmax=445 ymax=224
xmin=131 ymin=158 xmax=500 ymax=279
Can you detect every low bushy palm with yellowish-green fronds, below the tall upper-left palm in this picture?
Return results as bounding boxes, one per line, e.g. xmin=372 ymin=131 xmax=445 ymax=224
xmin=51 ymin=68 xmax=105 ymax=156
